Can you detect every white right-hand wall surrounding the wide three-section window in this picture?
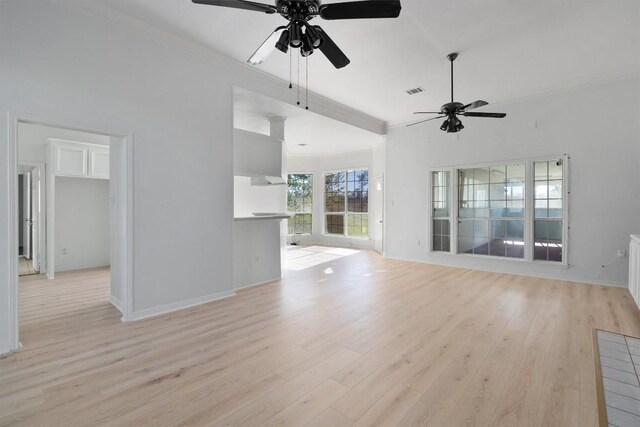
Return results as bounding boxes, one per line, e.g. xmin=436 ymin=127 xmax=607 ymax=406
xmin=386 ymin=77 xmax=640 ymax=285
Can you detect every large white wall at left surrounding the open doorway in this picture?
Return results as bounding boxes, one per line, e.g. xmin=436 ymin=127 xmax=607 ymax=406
xmin=0 ymin=0 xmax=384 ymax=352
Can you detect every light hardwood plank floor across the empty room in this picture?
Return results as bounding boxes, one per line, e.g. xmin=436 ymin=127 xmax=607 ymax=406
xmin=0 ymin=252 xmax=640 ymax=427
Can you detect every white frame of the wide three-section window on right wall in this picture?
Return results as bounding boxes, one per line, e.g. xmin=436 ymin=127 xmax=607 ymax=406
xmin=427 ymin=154 xmax=571 ymax=268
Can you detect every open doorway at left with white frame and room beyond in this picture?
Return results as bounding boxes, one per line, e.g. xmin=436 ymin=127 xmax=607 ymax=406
xmin=9 ymin=114 xmax=133 ymax=350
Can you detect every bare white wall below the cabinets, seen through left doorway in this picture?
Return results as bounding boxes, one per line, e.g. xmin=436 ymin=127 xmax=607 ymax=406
xmin=55 ymin=176 xmax=110 ymax=272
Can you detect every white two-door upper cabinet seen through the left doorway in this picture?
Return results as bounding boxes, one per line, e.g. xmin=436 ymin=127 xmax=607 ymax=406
xmin=49 ymin=139 xmax=109 ymax=179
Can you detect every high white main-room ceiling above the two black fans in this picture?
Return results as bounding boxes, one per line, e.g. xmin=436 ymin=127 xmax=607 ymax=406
xmin=102 ymin=0 xmax=640 ymax=124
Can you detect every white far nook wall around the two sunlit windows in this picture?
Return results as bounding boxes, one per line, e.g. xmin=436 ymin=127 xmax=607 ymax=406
xmin=288 ymin=148 xmax=384 ymax=249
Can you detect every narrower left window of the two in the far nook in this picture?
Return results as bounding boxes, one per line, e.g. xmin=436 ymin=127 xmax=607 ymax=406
xmin=287 ymin=174 xmax=313 ymax=234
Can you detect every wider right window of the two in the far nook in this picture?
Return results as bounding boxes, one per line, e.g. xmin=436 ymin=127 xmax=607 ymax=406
xmin=324 ymin=169 xmax=369 ymax=238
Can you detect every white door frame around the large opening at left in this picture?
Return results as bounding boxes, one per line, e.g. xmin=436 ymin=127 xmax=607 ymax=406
xmin=6 ymin=111 xmax=134 ymax=351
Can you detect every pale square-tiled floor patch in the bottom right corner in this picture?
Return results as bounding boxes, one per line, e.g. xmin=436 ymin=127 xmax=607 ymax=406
xmin=598 ymin=331 xmax=640 ymax=427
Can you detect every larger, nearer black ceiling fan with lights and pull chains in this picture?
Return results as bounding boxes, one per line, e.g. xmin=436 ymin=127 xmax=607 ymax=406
xmin=192 ymin=0 xmax=402 ymax=68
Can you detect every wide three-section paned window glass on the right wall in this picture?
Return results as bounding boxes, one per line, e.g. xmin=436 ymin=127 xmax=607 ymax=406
xmin=431 ymin=157 xmax=568 ymax=262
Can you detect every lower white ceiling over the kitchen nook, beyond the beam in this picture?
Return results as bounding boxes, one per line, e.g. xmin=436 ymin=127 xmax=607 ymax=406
xmin=233 ymin=88 xmax=382 ymax=157
